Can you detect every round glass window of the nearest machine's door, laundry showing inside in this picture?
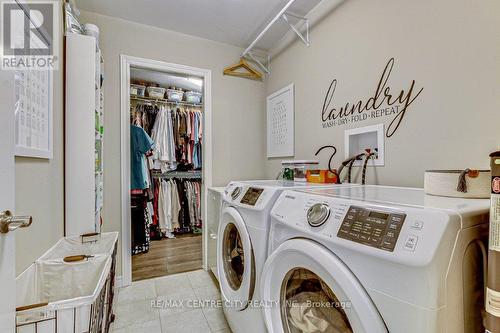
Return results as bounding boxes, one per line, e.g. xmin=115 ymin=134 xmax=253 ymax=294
xmin=281 ymin=268 xmax=352 ymax=333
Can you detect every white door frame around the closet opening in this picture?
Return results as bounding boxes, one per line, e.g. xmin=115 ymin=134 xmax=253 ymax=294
xmin=120 ymin=54 xmax=212 ymax=286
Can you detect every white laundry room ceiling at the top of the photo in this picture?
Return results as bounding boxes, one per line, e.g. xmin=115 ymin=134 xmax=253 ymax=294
xmin=76 ymin=0 xmax=321 ymax=50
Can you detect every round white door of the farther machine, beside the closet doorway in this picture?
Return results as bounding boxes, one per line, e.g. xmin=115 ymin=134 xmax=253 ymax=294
xmin=217 ymin=207 xmax=255 ymax=311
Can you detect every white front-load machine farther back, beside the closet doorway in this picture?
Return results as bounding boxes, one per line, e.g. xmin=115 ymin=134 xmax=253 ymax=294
xmin=217 ymin=180 xmax=353 ymax=333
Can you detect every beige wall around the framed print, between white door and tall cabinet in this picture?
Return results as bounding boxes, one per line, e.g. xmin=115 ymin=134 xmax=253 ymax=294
xmin=15 ymin=1 xmax=64 ymax=274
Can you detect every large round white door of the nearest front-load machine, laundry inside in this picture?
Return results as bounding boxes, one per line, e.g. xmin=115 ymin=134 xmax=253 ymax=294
xmin=260 ymin=239 xmax=388 ymax=333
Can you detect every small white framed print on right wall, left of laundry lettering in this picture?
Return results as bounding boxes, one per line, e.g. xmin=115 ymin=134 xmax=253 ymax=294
xmin=267 ymin=83 xmax=295 ymax=157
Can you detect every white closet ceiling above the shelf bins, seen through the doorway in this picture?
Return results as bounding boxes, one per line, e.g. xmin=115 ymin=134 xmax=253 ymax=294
xmin=130 ymin=68 xmax=203 ymax=92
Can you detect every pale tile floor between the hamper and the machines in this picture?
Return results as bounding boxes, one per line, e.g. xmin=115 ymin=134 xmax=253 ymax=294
xmin=111 ymin=270 xmax=231 ymax=333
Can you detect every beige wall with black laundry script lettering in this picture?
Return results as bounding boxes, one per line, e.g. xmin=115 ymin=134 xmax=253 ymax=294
xmin=266 ymin=0 xmax=500 ymax=186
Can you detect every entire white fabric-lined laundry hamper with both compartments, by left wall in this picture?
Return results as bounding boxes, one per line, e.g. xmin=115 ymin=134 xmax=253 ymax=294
xmin=16 ymin=233 xmax=118 ymax=333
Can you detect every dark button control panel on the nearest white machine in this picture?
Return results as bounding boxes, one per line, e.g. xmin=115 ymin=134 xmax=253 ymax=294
xmin=337 ymin=206 xmax=406 ymax=252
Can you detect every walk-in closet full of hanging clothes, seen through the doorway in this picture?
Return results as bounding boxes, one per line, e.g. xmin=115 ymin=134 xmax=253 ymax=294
xmin=130 ymin=68 xmax=204 ymax=281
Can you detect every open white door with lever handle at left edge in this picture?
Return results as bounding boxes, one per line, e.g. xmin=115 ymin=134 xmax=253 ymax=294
xmin=0 ymin=70 xmax=16 ymax=333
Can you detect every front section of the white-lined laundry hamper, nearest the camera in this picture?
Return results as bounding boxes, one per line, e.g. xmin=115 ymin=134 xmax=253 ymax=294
xmin=16 ymin=255 xmax=112 ymax=333
